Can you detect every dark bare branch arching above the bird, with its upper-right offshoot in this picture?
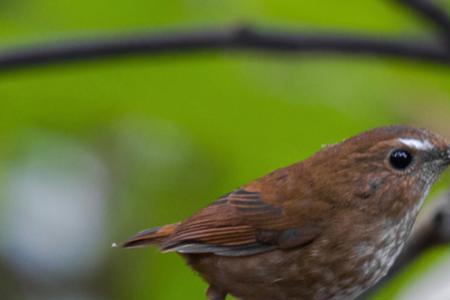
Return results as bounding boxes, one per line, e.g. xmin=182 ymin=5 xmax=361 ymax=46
xmin=0 ymin=0 xmax=450 ymax=72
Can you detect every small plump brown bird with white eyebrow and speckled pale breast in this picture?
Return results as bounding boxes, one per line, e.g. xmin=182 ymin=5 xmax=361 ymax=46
xmin=123 ymin=126 xmax=450 ymax=300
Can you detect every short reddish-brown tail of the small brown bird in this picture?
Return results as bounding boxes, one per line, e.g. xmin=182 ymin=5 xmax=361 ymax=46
xmin=122 ymin=223 xmax=178 ymax=248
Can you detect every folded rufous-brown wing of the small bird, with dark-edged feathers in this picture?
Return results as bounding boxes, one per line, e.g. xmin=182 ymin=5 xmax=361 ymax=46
xmin=162 ymin=189 xmax=323 ymax=256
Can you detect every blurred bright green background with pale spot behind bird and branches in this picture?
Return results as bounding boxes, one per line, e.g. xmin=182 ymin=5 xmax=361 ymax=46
xmin=0 ymin=0 xmax=450 ymax=300
